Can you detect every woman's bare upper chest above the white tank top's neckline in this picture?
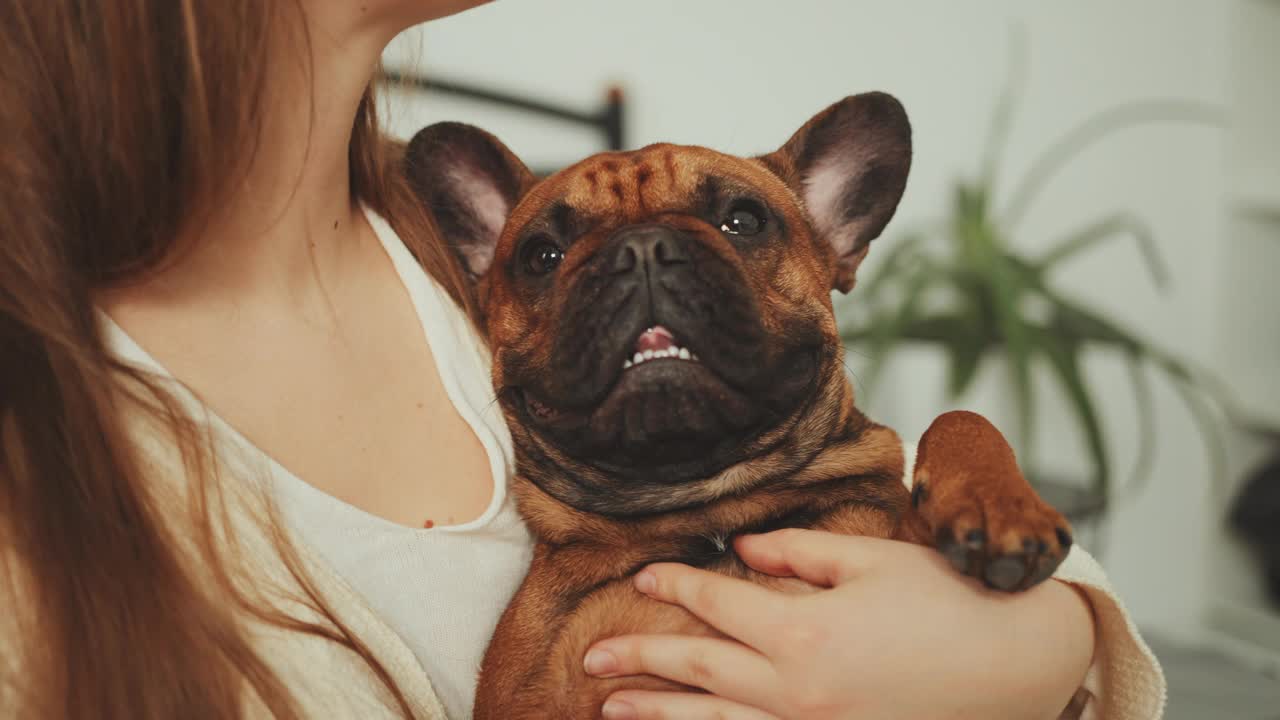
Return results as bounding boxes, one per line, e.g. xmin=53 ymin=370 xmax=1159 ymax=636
xmin=113 ymin=253 xmax=500 ymax=528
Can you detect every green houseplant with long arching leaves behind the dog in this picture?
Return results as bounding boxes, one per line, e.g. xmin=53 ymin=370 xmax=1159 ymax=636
xmin=840 ymin=74 xmax=1222 ymax=514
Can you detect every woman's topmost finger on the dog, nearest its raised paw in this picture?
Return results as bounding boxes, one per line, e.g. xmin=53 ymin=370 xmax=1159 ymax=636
xmin=733 ymin=529 xmax=891 ymax=588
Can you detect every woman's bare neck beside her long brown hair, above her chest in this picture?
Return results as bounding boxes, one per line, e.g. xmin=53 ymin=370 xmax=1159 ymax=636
xmin=129 ymin=3 xmax=394 ymax=306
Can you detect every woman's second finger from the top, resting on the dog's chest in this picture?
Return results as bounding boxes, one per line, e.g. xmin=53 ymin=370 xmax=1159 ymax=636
xmin=635 ymin=562 xmax=791 ymax=652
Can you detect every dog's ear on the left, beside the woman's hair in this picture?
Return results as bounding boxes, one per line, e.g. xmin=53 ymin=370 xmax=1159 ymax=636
xmin=404 ymin=123 xmax=535 ymax=279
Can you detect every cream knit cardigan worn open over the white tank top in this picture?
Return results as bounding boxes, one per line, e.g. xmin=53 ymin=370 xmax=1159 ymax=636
xmin=0 ymin=392 xmax=1165 ymax=720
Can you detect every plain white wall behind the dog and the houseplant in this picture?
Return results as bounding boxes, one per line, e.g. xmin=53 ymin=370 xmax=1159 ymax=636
xmin=390 ymin=0 xmax=1228 ymax=628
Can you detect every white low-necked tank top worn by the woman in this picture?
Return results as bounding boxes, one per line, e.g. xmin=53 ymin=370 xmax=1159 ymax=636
xmin=104 ymin=209 xmax=532 ymax=720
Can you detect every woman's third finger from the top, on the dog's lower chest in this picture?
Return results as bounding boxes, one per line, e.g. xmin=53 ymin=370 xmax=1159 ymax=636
xmin=584 ymin=635 xmax=778 ymax=705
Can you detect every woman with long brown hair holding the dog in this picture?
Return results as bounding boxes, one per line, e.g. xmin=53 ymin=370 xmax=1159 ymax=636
xmin=0 ymin=0 xmax=1162 ymax=720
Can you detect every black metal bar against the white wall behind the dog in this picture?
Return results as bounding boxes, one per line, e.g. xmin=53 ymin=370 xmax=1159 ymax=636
xmin=383 ymin=70 xmax=627 ymax=156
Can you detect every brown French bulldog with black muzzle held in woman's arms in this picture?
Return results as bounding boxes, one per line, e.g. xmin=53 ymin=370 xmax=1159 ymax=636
xmin=407 ymin=94 xmax=1071 ymax=720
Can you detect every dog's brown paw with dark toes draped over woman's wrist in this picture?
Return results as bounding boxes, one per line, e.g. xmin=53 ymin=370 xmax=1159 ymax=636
xmin=911 ymin=473 xmax=1071 ymax=592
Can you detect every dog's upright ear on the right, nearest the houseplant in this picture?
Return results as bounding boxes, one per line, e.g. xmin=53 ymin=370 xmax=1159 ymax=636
xmin=760 ymin=92 xmax=911 ymax=292
